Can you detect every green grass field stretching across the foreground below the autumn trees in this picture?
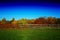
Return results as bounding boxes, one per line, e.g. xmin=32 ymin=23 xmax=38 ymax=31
xmin=0 ymin=28 xmax=60 ymax=40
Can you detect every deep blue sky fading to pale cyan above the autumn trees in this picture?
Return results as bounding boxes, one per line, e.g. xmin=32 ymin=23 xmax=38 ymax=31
xmin=0 ymin=0 xmax=60 ymax=20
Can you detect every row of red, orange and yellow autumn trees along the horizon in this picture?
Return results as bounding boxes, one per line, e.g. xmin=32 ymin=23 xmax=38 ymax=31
xmin=0 ymin=17 xmax=60 ymax=28
